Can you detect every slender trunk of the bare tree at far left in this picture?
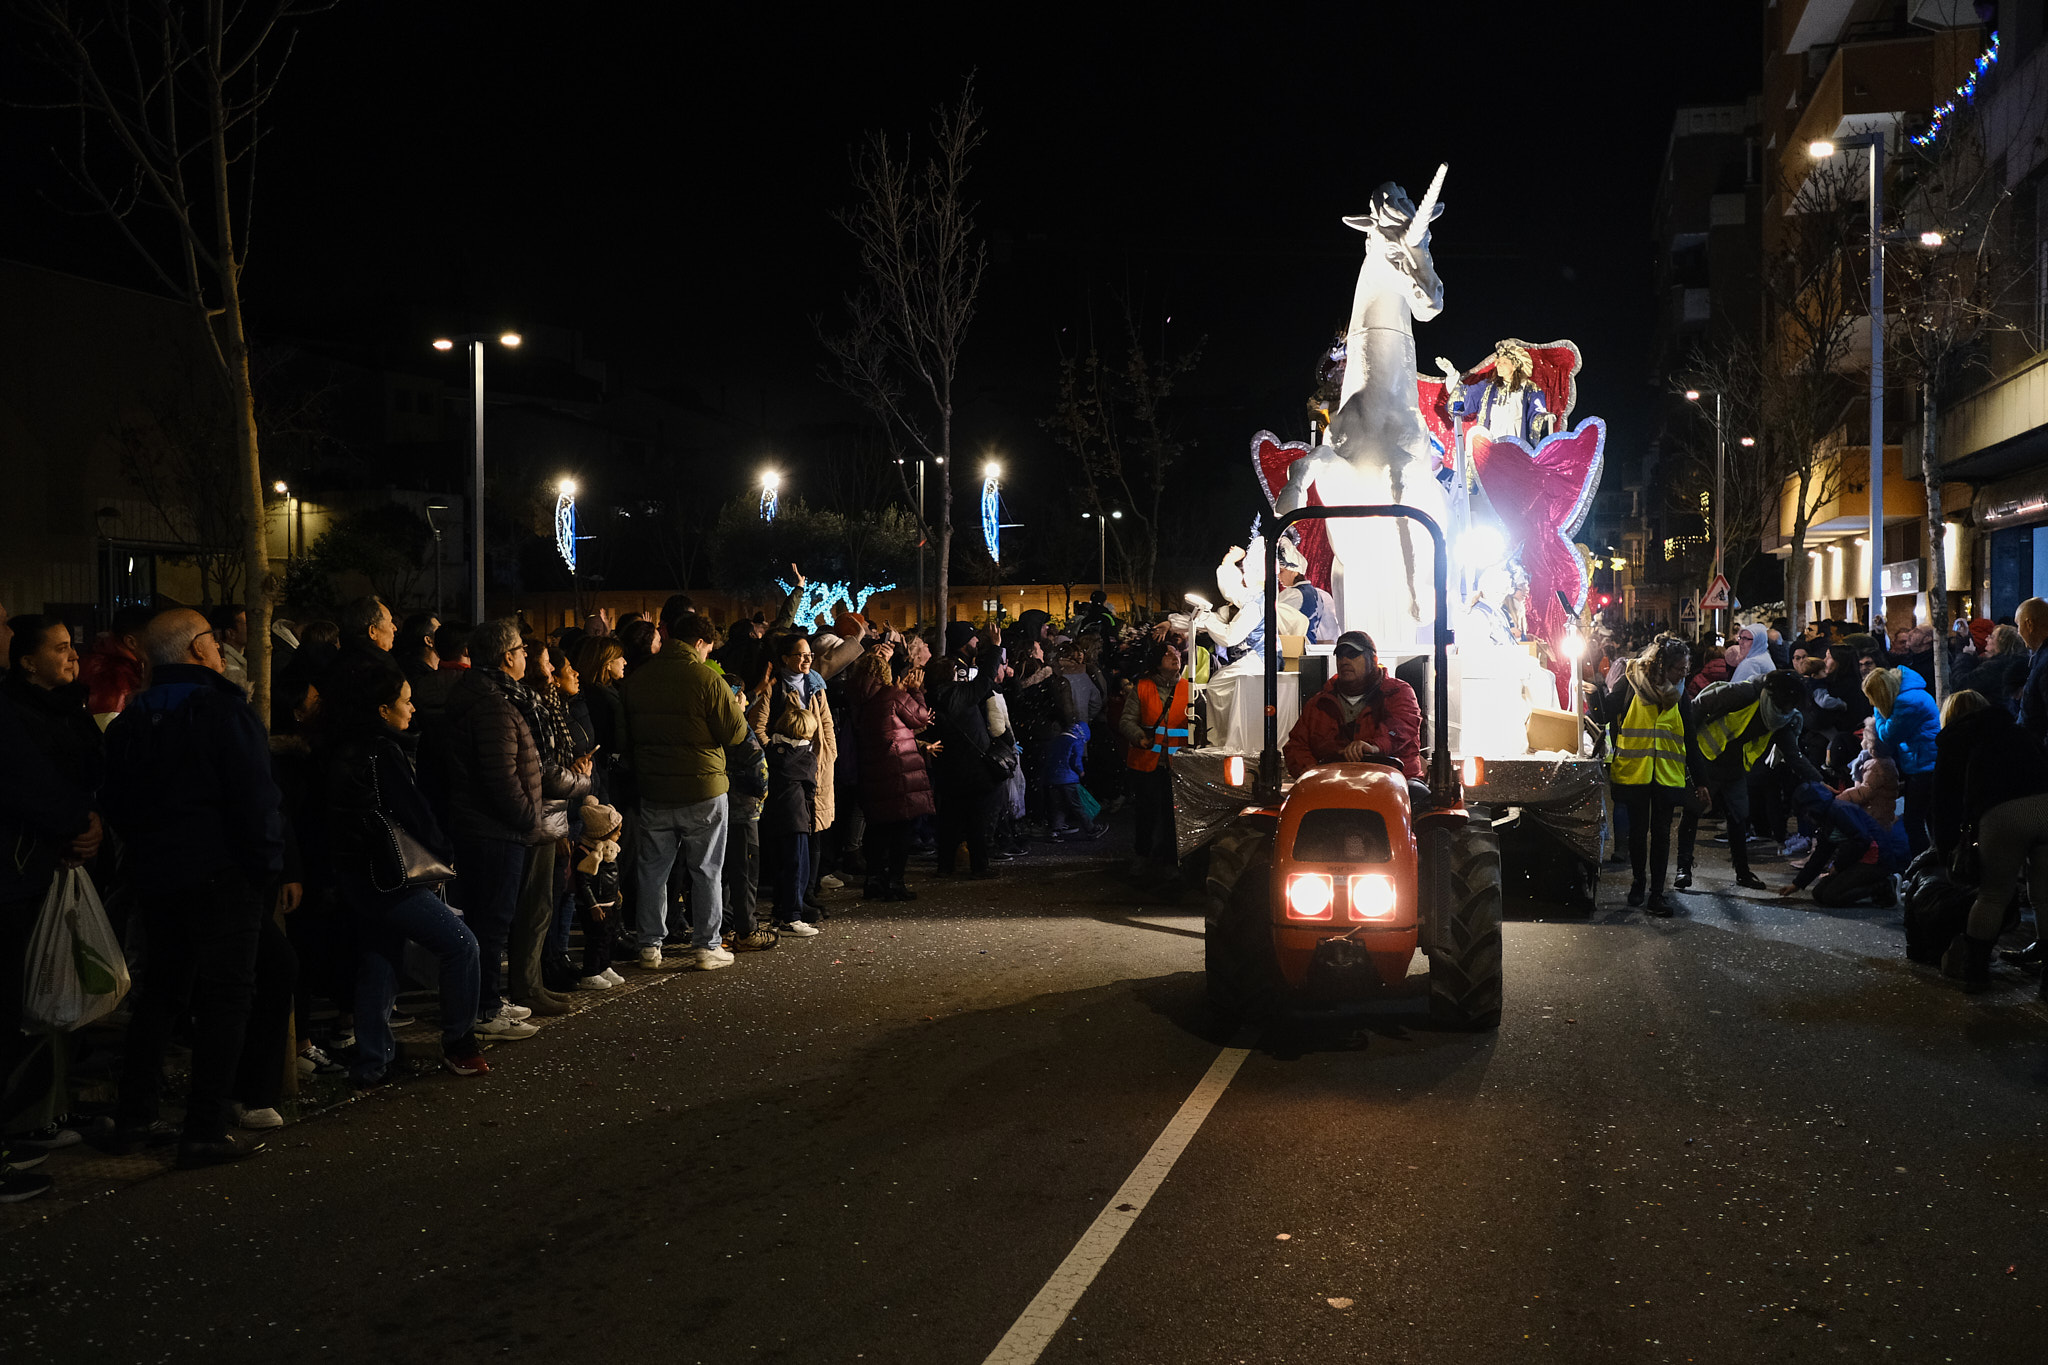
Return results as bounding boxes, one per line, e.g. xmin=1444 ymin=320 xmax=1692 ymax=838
xmin=207 ymin=34 xmax=270 ymax=729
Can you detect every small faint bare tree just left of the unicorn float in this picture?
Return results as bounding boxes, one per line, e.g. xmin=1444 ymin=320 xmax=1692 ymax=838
xmin=1044 ymin=313 xmax=1202 ymax=602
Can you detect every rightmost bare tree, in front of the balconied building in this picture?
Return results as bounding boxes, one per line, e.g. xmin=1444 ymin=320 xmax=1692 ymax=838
xmin=1884 ymin=106 xmax=2017 ymax=698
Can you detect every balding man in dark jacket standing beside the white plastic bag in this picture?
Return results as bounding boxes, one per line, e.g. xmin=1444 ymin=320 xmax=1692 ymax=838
xmin=100 ymin=608 xmax=285 ymax=1166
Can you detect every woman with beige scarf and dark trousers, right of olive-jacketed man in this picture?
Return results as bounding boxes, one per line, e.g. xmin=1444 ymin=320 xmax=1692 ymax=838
xmin=748 ymin=634 xmax=838 ymax=937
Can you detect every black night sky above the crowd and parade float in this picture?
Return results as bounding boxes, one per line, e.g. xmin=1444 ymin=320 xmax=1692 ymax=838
xmin=0 ymin=0 xmax=1761 ymax=593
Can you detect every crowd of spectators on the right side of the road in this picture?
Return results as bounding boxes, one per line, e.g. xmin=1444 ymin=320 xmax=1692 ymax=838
xmin=1585 ymin=598 xmax=2048 ymax=993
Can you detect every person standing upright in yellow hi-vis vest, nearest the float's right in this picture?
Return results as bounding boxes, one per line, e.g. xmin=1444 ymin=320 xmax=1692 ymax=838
xmin=1597 ymin=634 xmax=1706 ymax=915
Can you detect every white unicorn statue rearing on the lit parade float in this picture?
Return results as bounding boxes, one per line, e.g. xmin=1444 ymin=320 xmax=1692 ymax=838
xmin=1276 ymin=166 xmax=1454 ymax=651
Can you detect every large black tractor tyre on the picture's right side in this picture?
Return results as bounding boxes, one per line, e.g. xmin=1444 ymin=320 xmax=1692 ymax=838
xmin=1421 ymin=825 xmax=1501 ymax=1029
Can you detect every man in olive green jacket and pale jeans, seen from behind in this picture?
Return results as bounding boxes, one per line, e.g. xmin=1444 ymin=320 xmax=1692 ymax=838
xmin=618 ymin=604 xmax=748 ymax=972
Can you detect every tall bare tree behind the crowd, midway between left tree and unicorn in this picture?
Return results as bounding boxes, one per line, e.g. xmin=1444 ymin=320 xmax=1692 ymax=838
xmin=819 ymin=87 xmax=987 ymax=634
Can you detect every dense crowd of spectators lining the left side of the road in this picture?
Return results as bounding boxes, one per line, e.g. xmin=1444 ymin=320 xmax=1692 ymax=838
xmin=0 ymin=575 xmax=1190 ymax=1199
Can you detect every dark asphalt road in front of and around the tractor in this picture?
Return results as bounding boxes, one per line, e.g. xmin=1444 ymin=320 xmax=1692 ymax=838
xmin=0 ymin=826 xmax=2048 ymax=1365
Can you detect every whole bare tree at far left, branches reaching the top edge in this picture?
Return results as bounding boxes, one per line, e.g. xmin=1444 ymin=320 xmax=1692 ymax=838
xmin=20 ymin=0 xmax=334 ymax=718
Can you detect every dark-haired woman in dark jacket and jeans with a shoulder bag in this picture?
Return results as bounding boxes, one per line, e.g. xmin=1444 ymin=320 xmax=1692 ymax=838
xmin=328 ymin=669 xmax=489 ymax=1085
